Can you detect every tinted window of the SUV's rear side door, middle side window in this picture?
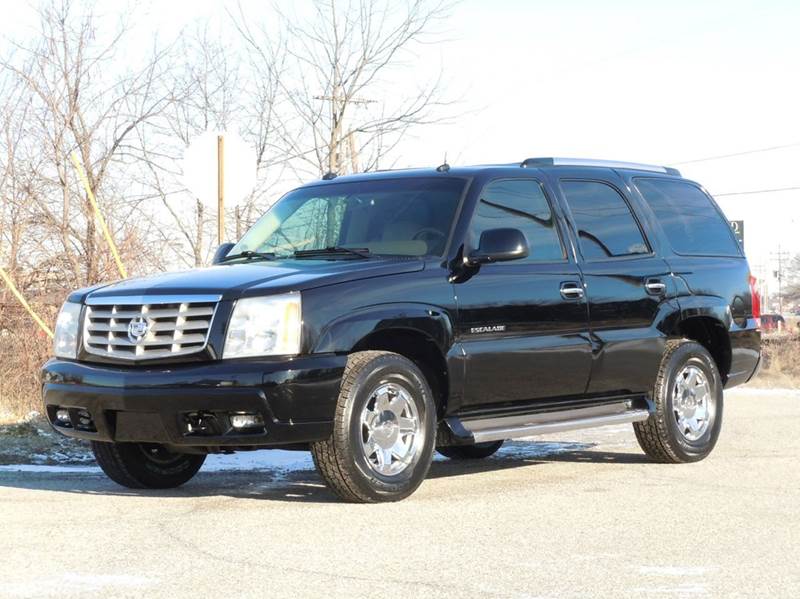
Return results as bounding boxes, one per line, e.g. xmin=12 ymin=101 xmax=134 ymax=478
xmin=561 ymin=181 xmax=650 ymax=260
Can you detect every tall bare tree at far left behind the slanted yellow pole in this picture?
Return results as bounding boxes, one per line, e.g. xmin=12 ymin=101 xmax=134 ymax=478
xmin=0 ymin=1 xmax=172 ymax=286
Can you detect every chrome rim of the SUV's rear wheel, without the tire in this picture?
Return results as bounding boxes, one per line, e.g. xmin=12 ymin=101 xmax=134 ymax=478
xmin=672 ymin=365 xmax=716 ymax=441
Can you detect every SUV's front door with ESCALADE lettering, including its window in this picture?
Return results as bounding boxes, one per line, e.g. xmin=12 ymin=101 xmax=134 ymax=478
xmin=454 ymin=178 xmax=591 ymax=407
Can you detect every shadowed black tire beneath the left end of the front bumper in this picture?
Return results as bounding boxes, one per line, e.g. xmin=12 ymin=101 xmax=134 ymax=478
xmin=92 ymin=441 xmax=206 ymax=489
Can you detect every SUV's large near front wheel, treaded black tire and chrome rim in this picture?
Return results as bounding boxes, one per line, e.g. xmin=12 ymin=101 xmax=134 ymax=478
xmin=311 ymin=351 xmax=436 ymax=503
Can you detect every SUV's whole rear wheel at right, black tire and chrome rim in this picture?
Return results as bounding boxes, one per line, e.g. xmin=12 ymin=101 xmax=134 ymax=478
xmin=633 ymin=339 xmax=723 ymax=464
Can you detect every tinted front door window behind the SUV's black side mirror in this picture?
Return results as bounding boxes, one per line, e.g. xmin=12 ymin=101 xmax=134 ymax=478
xmin=470 ymin=179 xmax=565 ymax=262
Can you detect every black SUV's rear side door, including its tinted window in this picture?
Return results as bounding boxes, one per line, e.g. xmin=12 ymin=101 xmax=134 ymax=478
xmin=558 ymin=169 xmax=675 ymax=395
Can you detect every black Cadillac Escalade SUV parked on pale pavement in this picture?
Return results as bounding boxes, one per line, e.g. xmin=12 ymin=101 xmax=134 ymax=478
xmin=43 ymin=158 xmax=760 ymax=502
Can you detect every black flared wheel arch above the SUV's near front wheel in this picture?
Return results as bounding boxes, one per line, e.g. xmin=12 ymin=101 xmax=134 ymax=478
xmin=312 ymin=303 xmax=453 ymax=355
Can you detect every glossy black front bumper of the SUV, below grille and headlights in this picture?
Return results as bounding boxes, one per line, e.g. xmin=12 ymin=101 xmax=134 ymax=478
xmin=42 ymin=354 xmax=347 ymax=448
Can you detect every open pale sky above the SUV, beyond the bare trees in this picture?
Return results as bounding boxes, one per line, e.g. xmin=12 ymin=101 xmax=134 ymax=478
xmin=0 ymin=0 xmax=800 ymax=300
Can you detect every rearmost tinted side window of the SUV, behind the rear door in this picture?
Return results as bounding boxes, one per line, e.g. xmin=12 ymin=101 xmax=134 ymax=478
xmin=634 ymin=179 xmax=739 ymax=256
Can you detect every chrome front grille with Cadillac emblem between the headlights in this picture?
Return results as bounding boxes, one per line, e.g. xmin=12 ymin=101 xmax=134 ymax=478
xmin=83 ymin=297 xmax=218 ymax=360
